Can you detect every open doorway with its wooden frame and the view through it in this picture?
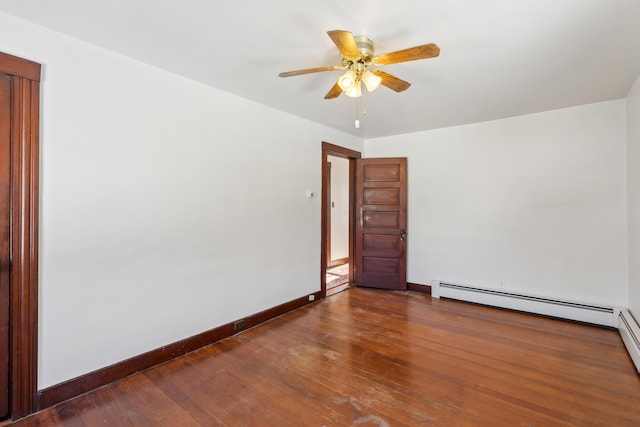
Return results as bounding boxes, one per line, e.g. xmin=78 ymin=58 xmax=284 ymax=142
xmin=321 ymin=142 xmax=361 ymax=296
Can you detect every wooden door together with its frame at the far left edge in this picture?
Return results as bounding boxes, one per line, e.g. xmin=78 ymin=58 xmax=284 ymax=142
xmin=0 ymin=52 xmax=41 ymax=424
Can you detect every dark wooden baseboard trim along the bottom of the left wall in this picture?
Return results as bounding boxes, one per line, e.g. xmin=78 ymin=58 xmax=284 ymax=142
xmin=38 ymin=291 xmax=322 ymax=409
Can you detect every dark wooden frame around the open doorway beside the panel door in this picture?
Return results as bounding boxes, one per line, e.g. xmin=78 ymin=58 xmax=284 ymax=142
xmin=320 ymin=141 xmax=362 ymax=298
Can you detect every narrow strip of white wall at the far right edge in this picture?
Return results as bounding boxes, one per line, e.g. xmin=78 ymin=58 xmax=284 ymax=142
xmin=627 ymin=73 xmax=640 ymax=321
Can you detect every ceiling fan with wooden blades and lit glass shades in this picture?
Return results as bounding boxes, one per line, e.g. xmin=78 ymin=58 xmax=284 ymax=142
xmin=279 ymin=30 xmax=440 ymax=99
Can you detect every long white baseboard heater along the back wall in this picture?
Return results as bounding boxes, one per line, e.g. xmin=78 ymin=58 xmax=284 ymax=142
xmin=432 ymin=282 xmax=616 ymax=330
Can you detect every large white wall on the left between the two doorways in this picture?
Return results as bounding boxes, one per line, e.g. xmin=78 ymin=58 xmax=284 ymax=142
xmin=0 ymin=13 xmax=363 ymax=388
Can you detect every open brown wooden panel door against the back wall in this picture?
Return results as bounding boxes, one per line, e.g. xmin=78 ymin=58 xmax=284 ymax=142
xmin=355 ymin=157 xmax=407 ymax=290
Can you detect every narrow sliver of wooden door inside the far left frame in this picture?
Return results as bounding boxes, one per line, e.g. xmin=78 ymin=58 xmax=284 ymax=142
xmin=0 ymin=74 xmax=11 ymax=420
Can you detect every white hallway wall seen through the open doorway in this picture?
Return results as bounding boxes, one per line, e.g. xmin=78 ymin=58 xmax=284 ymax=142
xmin=328 ymin=156 xmax=349 ymax=260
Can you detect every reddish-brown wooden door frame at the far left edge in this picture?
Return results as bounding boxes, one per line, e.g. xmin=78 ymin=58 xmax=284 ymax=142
xmin=0 ymin=52 xmax=41 ymax=419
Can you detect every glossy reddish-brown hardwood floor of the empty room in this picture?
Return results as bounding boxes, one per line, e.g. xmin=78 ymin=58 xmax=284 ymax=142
xmin=12 ymin=288 xmax=640 ymax=427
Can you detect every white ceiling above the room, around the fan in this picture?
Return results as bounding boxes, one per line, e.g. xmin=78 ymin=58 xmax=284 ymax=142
xmin=0 ymin=0 xmax=640 ymax=138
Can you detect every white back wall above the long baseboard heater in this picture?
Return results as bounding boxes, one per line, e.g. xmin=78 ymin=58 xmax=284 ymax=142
xmin=365 ymin=100 xmax=627 ymax=306
